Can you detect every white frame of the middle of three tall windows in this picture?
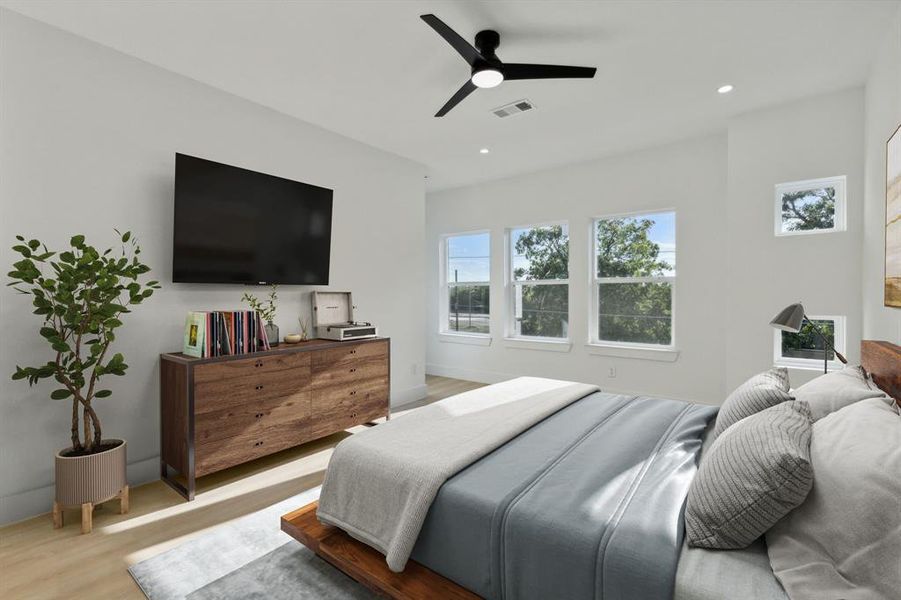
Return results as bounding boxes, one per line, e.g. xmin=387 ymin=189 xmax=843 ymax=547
xmin=504 ymin=219 xmax=572 ymax=342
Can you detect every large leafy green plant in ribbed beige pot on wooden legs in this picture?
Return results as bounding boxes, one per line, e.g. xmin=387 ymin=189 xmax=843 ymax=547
xmin=9 ymin=231 xmax=160 ymax=533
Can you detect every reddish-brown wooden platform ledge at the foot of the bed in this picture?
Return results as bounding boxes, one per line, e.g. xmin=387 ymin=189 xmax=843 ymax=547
xmin=282 ymin=502 xmax=479 ymax=600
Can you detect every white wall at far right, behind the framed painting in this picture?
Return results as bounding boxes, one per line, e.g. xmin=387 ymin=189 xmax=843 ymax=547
xmin=863 ymin=9 xmax=901 ymax=344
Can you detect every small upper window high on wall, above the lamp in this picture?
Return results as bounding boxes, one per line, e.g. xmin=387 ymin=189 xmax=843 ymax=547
xmin=776 ymin=175 xmax=845 ymax=236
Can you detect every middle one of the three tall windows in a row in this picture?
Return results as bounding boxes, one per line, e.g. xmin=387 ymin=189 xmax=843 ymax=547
xmin=508 ymin=224 xmax=569 ymax=339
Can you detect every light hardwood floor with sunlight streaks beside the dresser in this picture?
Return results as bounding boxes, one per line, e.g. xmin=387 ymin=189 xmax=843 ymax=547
xmin=0 ymin=376 xmax=481 ymax=600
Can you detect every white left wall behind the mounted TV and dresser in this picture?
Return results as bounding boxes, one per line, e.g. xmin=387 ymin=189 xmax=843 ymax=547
xmin=0 ymin=10 xmax=425 ymax=522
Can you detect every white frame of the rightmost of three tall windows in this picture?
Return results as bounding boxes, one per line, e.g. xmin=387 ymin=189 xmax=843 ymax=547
xmin=588 ymin=207 xmax=679 ymax=352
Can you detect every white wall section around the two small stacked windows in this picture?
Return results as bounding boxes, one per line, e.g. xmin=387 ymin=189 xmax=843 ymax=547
xmin=723 ymin=89 xmax=863 ymax=389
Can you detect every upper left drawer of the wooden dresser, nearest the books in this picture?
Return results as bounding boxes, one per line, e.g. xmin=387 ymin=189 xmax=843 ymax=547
xmin=194 ymin=366 xmax=310 ymax=414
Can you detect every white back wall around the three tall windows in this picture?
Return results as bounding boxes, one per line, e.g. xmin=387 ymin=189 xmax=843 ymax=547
xmin=426 ymin=136 xmax=726 ymax=403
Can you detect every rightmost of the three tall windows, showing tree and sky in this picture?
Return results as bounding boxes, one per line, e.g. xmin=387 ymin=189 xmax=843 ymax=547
xmin=590 ymin=212 xmax=676 ymax=346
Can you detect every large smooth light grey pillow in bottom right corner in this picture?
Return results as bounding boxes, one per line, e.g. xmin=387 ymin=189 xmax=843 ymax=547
xmin=766 ymin=398 xmax=901 ymax=600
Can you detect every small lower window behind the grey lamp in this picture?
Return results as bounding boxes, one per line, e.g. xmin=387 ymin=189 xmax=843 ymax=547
xmin=773 ymin=316 xmax=845 ymax=370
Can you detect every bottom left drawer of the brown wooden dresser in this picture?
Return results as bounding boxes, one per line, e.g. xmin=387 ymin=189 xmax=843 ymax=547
xmin=194 ymin=415 xmax=312 ymax=477
